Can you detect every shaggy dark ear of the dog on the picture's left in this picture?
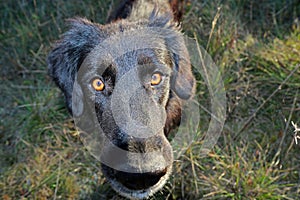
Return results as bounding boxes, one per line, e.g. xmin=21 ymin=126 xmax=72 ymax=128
xmin=47 ymin=18 xmax=104 ymax=115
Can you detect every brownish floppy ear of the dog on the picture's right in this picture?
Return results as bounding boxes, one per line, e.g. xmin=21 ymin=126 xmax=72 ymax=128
xmin=149 ymin=13 xmax=196 ymax=99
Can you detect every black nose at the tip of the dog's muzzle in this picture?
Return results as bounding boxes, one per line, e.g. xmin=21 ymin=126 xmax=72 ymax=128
xmin=115 ymin=168 xmax=167 ymax=190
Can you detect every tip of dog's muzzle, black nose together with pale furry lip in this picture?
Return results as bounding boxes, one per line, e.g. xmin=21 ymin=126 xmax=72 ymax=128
xmin=102 ymin=165 xmax=172 ymax=199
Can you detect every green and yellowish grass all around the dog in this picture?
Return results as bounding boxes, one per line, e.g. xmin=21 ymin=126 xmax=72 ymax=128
xmin=0 ymin=0 xmax=300 ymax=200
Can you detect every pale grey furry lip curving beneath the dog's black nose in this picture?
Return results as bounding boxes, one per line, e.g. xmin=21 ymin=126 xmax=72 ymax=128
xmin=106 ymin=165 xmax=172 ymax=199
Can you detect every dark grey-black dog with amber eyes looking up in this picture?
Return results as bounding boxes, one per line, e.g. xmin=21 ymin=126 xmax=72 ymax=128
xmin=47 ymin=0 xmax=195 ymax=199
